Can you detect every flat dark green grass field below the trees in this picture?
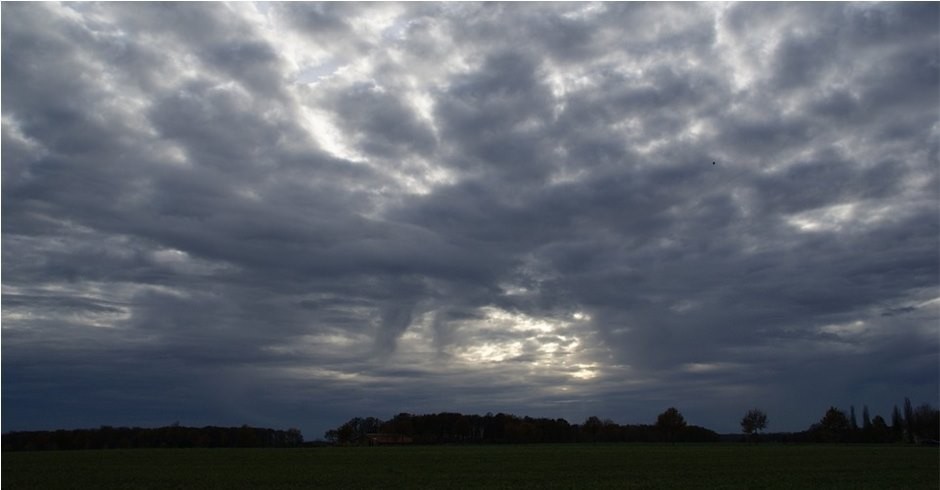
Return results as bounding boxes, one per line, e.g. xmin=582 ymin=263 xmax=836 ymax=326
xmin=2 ymin=444 xmax=940 ymax=490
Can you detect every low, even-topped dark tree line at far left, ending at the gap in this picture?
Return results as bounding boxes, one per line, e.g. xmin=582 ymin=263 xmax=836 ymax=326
xmin=3 ymin=424 xmax=304 ymax=451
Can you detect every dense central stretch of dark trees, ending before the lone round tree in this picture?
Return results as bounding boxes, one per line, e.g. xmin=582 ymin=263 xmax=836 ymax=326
xmin=324 ymin=408 xmax=718 ymax=445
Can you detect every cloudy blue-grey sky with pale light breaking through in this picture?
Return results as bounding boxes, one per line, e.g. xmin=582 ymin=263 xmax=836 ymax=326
xmin=2 ymin=2 xmax=940 ymax=440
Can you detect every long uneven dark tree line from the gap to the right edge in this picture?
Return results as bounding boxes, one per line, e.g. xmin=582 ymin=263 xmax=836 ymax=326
xmin=324 ymin=398 xmax=940 ymax=445
